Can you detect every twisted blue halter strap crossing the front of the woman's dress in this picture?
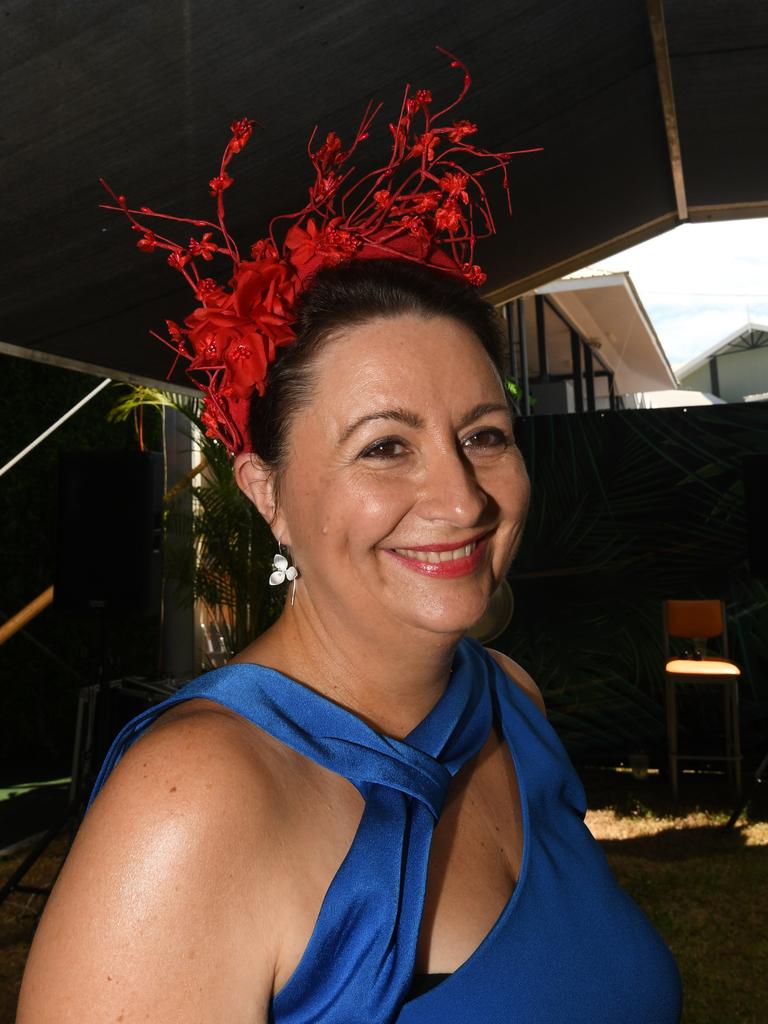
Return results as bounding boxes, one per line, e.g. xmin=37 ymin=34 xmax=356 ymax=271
xmin=88 ymin=639 xmax=493 ymax=1024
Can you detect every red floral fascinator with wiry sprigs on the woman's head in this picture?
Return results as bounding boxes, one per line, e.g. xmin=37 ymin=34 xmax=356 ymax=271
xmin=101 ymin=51 xmax=536 ymax=454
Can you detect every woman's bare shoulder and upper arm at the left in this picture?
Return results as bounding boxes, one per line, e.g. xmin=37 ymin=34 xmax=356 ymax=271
xmin=17 ymin=700 xmax=280 ymax=1024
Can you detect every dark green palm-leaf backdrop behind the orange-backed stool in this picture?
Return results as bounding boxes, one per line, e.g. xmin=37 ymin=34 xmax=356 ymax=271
xmin=505 ymin=402 xmax=768 ymax=763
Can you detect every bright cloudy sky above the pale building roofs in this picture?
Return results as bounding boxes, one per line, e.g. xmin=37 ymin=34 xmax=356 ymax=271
xmin=588 ymin=217 xmax=768 ymax=369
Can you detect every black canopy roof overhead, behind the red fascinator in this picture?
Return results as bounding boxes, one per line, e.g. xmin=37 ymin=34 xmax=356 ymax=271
xmin=0 ymin=0 xmax=768 ymax=389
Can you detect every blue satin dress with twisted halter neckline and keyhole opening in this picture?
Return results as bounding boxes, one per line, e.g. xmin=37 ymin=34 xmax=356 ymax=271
xmin=89 ymin=639 xmax=681 ymax=1024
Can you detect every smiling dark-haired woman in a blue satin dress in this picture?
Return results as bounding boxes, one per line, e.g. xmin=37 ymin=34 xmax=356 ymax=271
xmin=18 ymin=58 xmax=679 ymax=1024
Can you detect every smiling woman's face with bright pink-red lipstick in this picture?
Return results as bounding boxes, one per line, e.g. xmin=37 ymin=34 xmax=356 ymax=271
xmin=252 ymin=314 xmax=529 ymax=634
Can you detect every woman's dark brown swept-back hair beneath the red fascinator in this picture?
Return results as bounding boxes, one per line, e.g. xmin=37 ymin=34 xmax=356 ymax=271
xmin=249 ymin=259 xmax=503 ymax=473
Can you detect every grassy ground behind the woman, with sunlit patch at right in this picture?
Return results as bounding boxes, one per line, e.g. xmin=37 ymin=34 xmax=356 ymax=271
xmin=0 ymin=770 xmax=768 ymax=1024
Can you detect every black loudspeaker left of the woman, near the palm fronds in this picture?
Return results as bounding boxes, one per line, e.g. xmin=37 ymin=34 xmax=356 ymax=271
xmin=53 ymin=452 xmax=163 ymax=616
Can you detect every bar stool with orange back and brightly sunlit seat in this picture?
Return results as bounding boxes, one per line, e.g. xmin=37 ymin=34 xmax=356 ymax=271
xmin=664 ymin=600 xmax=741 ymax=800
